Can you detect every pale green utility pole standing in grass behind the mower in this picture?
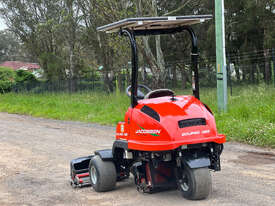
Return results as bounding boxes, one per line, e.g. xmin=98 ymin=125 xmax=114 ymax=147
xmin=215 ymin=0 xmax=227 ymax=112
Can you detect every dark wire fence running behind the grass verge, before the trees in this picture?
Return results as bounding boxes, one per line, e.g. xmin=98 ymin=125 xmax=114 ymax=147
xmin=9 ymin=49 xmax=275 ymax=93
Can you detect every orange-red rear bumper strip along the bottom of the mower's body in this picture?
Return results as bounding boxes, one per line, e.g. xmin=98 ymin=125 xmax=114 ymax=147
xmin=128 ymin=134 xmax=226 ymax=151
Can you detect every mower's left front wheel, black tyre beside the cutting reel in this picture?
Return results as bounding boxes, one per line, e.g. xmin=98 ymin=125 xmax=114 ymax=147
xmin=89 ymin=155 xmax=117 ymax=192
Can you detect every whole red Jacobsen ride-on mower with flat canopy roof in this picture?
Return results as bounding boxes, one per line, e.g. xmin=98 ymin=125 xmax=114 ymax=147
xmin=71 ymin=15 xmax=225 ymax=200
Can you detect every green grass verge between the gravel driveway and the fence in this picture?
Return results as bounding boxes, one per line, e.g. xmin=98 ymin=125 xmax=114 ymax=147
xmin=0 ymin=86 xmax=275 ymax=148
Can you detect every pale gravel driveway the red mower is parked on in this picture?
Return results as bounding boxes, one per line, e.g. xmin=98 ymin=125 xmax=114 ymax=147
xmin=0 ymin=113 xmax=275 ymax=206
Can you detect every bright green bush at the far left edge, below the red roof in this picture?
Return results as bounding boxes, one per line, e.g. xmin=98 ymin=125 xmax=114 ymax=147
xmin=0 ymin=67 xmax=16 ymax=93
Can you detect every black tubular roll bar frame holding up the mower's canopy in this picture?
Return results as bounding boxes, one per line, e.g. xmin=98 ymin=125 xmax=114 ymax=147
xmin=120 ymin=26 xmax=200 ymax=108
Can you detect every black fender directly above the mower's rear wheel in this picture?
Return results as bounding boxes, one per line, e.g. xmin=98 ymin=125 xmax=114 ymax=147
xmin=181 ymin=152 xmax=211 ymax=169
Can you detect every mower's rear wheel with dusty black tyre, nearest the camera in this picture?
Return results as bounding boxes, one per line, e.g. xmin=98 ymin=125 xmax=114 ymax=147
xmin=178 ymin=166 xmax=212 ymax=200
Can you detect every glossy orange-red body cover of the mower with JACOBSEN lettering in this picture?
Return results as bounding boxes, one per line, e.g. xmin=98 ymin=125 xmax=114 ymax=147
xmin=116 ymin=96 xmax=226 ymax=151
